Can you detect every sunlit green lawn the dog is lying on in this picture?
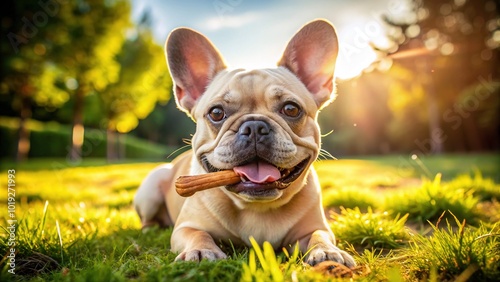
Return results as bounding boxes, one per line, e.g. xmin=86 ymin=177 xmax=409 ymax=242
xmin=0 ymin=155 xmax=500 ymax=281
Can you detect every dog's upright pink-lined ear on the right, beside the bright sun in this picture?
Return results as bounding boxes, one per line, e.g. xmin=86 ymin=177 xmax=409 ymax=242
xmin=278 ymin=20 xmax=339 ymax=108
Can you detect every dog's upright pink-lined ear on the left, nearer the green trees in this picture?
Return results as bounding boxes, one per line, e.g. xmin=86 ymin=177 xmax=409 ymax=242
xmin=165 ymin=28 xmax=226 ymax=114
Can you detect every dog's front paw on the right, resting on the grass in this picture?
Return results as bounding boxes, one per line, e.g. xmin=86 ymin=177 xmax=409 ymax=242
xmin=300 ymin=230 xmax=356 ymax=267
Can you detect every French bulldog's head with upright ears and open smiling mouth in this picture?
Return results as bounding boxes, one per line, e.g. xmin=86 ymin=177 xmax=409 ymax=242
xmin=166 ymin=20 xmax=338 ymax=206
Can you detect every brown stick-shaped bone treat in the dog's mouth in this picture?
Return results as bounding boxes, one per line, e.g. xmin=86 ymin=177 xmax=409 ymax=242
xmin=175 ymin=170 xmax=241 ymax=197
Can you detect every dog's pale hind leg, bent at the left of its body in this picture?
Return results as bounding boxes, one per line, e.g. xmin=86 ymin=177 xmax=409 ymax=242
xmin=134 ymin=164 xmax=174 ymax=229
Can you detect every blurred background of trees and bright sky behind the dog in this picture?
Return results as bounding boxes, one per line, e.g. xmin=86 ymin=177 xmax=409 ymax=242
xmin=0 ymin=0 xmax=500 ymax=163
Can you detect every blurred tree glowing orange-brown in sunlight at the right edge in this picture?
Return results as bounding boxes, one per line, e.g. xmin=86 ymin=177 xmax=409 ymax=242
xmin=385 ymin=0 xmax=500 ymax=153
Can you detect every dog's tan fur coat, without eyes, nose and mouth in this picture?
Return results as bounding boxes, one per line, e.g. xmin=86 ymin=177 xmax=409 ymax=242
xmin=134 ymin=21 xmax=355 ymax=266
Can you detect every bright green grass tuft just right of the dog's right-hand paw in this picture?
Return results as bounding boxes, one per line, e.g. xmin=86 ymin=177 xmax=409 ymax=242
xmin=330 ymin=208 xmax=410 ymax=249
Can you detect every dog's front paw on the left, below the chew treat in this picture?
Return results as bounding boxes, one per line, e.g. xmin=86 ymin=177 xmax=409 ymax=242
xmin=171 ymin=227 xmax=227 ymax=262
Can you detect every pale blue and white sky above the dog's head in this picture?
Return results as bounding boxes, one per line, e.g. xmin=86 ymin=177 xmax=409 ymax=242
xmin=132 ymin=0 xmax=407 ymax=79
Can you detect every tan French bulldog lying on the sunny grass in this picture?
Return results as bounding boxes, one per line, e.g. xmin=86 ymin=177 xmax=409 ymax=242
xmin=134 ymin=20 xmax=356 ymax=267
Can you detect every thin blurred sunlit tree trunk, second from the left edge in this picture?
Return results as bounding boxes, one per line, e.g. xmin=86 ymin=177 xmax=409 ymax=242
xmin=70 ymin=86 xmax=85 ymax=161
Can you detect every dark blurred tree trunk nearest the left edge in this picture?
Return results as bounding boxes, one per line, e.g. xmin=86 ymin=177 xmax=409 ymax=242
xmin=16 ymin=93 xmax=31 ymax=162
